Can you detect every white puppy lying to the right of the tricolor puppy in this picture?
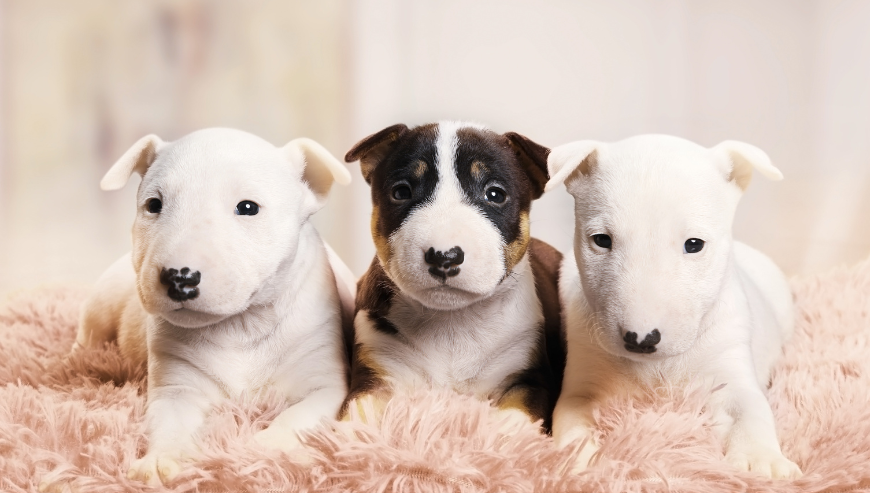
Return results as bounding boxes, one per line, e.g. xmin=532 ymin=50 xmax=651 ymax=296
xmin=547 ymin=135 xmax=801 ymax=478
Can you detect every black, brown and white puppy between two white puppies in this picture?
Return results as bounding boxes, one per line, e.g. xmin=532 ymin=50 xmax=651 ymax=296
xmin=345 ymin=122 xmax=564 ymax=426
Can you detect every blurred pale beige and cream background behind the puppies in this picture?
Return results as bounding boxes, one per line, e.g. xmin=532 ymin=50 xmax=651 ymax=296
xmin=0 ymin=0 xmax=870 ymax=297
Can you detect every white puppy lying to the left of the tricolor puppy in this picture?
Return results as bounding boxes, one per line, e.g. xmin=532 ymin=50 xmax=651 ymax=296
xmin=76 ymin=128 xmax=355 ymax=485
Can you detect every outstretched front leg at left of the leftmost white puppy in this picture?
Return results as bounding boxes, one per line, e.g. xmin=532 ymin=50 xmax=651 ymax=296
xmin=127 ymin=385 xmax=211 ymax=486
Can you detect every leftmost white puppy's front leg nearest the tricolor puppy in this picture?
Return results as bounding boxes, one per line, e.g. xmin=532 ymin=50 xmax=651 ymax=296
xmin=254 ymin=386 xmax=347 ymax=451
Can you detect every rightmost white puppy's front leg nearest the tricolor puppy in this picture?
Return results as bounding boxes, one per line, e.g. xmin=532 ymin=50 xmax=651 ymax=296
xmin=553 ymin=391 xmax=600 ymax=473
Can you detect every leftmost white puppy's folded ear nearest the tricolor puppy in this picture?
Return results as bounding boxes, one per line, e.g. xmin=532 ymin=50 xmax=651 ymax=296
xmin=283 ymin=137 xmax=350 ymax=205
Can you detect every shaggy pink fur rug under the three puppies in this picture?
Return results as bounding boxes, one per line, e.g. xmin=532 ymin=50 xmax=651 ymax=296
xmin=0 ymin=260 xmax=870 ymax=492
